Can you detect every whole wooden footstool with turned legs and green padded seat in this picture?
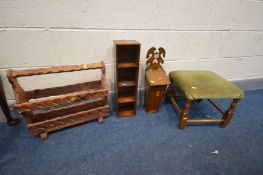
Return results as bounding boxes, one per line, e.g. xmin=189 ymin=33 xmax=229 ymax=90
xmin=168 ymin=70 xmax=244 ymax=128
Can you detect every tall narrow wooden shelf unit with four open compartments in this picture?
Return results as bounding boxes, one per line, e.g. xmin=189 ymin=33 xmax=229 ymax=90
xmin=114 ymin=40 xmax=141 ymax=117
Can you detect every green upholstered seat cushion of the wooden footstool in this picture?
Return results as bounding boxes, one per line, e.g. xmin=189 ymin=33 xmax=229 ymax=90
xmin=169 ymin=70 xmax=244 ymax=100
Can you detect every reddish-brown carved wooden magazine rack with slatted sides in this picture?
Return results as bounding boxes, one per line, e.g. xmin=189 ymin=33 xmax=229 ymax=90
xmin=7 ymin=62 xmax=109 ymax=139
